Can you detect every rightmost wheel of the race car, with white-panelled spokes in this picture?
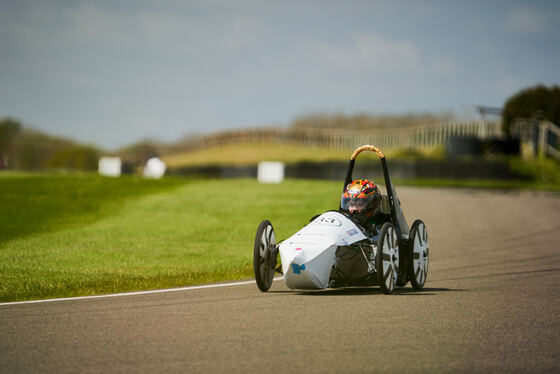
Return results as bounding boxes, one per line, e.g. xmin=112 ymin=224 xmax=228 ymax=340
xmin=408 ymin=219 xmax=430 ymax=290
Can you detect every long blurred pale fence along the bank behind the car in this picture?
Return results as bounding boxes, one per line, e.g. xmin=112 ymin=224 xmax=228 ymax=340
xmin=182 ymin=122 xmax=502 ymax=150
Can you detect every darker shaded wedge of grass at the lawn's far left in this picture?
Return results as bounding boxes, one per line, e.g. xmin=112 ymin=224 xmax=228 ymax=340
xmin=0 ymin=172 xmax=189 ymax=244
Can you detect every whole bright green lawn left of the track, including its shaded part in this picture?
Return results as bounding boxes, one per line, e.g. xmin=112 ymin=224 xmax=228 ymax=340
xmin=0 ymin=175 xmax=340 ymax=301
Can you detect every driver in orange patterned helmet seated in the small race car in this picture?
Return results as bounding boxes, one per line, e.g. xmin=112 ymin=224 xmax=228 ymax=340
xmin=340 ymin=179 xmax=391 ymax=231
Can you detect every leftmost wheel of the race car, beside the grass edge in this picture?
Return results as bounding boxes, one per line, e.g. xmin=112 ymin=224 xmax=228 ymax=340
xmin=253 ymin=220 xmax=278 ymax=292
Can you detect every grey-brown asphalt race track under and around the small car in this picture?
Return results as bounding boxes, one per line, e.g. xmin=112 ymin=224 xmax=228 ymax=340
xmin=0 ymin=188 xmax=560 ymax=373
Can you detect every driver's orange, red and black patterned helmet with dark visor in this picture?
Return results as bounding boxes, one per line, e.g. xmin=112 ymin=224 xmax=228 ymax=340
xmin=340 ymin=179 xmax=381 ymax=223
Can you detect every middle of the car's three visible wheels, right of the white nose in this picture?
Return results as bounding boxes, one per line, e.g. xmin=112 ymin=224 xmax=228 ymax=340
xmin=375 ymin=222 xmax=399 ymax=295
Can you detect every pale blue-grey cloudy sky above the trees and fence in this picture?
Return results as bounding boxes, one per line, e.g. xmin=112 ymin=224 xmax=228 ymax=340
xmin=0 ymin=0 xmax=560 ymax=149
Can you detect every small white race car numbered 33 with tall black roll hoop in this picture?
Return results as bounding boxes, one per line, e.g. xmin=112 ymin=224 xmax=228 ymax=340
xmin=253 ymin=145 xmax=430 ymax=294
